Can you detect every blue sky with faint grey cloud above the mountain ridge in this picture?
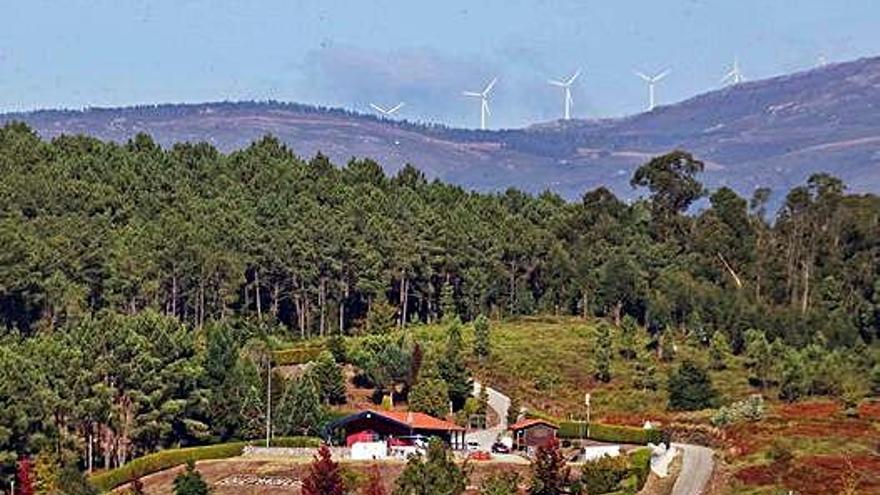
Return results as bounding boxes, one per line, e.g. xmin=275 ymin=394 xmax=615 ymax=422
xmin=0 ymin=0 xmax=880 ymax=128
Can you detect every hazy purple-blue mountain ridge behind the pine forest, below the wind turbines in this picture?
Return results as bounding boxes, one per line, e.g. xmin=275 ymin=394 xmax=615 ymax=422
xmin=0 ymin=58 xmax=880 ymax=203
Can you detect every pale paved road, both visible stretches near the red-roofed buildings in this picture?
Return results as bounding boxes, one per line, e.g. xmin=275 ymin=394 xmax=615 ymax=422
xmin=465 ymin=382 xmax=715 ymax=495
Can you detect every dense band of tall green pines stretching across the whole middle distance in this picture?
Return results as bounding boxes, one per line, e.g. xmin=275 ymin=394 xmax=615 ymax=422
xmin=0 ymin=124 xmax=880 ymax=349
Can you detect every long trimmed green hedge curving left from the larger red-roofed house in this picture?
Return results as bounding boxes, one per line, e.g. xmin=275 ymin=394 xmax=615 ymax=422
xmin=89 ymin=437 xmax=320 ymax=493
